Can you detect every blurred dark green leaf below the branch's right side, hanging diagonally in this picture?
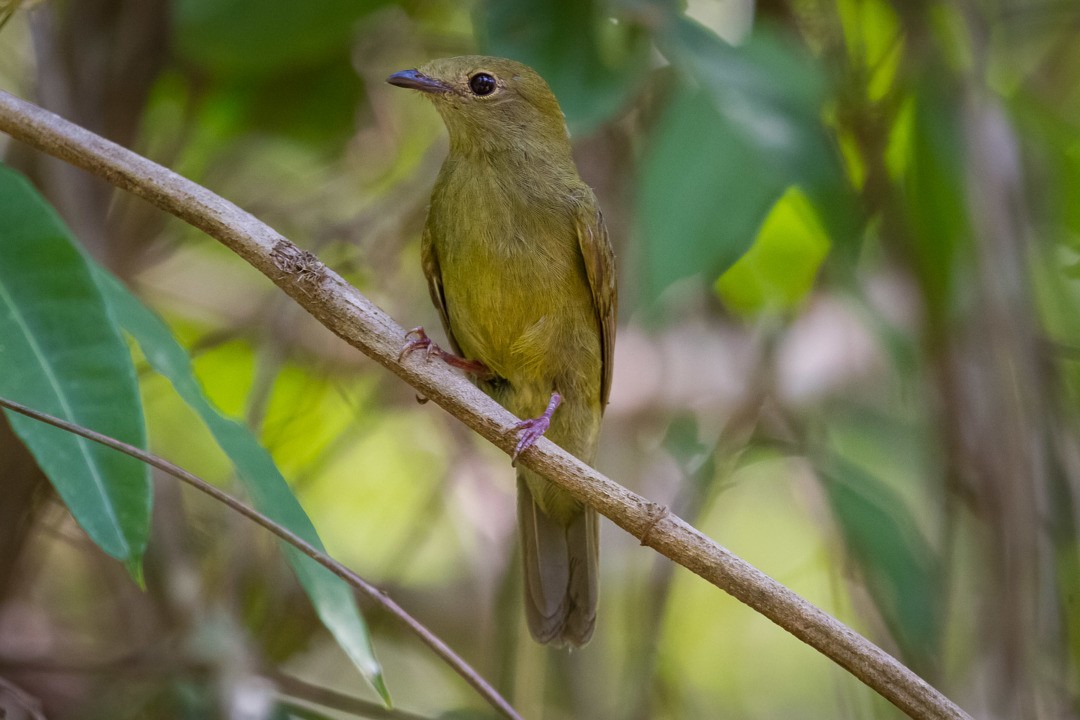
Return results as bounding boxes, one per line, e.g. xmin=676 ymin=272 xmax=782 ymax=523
xmin=822 ymin=452 xmax=945 ymax=677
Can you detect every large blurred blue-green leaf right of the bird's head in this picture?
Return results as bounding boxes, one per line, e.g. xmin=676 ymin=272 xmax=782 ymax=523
xmin=637 ymin=15 xmax=859 ymax=299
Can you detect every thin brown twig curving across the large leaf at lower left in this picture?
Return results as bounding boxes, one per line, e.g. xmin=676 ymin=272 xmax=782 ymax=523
xmin=0 ymin=397 xmax=521 ymax=720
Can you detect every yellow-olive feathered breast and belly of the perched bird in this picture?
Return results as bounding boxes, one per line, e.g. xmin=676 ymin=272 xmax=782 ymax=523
xmin=429 ymin=165 xmax=598 ymax=383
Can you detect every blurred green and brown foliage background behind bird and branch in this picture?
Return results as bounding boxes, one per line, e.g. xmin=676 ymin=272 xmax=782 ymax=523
xmin=0 ymin=0 xmax=1080 ymax=720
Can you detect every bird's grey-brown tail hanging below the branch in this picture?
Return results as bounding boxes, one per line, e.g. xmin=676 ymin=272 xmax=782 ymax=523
xmin=517 ymin=471 xmax=599 ymax=648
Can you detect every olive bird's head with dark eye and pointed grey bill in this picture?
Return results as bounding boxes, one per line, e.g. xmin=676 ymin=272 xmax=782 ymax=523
xmin=387 ymin=55 xmax=569 ymax=153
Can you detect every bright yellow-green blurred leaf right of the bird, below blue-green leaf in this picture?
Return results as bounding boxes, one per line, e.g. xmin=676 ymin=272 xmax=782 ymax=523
xmin=716 ymin=187 xmax=829 ymax=314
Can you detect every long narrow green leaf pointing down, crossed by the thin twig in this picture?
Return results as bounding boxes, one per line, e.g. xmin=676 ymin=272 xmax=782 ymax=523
xmin=96 ymin=268 xmax=390 ymax=706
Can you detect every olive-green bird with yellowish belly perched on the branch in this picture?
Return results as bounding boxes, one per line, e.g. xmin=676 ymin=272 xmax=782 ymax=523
xmin=388 ymin=56 xmax=616 ymax=646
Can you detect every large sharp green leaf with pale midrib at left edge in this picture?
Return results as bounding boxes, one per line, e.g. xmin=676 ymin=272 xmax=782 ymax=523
xmin=0 ymin=166 xmax=151 ymax=565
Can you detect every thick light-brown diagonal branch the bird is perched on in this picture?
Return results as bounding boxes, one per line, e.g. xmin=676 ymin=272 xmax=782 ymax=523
xmin=0 ymin=92 xmax=970 ymax=720
